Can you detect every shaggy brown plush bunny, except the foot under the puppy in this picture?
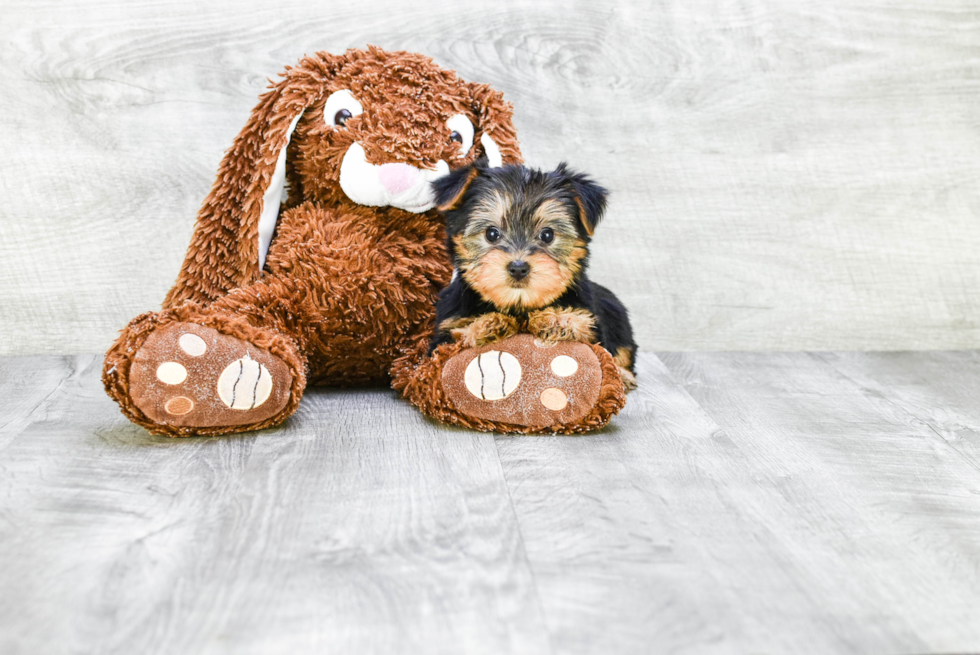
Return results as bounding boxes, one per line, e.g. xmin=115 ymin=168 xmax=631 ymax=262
xmin=103 ymin=47 xmax=521 ymax=436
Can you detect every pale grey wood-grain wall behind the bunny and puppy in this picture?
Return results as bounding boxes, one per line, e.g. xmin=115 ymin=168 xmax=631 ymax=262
xmin=0 ymin=0 xmax=980 ymax=354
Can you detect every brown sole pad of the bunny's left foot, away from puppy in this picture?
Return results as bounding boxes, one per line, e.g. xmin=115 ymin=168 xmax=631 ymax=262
xmin=129 ymin=322 xmax=292 ymax=428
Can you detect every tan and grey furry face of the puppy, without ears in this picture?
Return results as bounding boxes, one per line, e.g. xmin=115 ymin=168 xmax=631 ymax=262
xmin=454 ymin=189 xmax=588 ymax=310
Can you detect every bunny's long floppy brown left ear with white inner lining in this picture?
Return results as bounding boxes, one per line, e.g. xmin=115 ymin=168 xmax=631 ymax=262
xmin=163 ymin=53 xmax=340 ymax=309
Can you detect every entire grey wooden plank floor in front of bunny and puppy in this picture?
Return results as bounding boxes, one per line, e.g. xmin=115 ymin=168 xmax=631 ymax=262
xmin=0 ymin=352 xmax=980 ymax=655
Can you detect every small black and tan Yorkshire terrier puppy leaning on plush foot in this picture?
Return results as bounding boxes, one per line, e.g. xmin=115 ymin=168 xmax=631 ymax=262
xmin=429 ymin=162 xmax=636 ymax=391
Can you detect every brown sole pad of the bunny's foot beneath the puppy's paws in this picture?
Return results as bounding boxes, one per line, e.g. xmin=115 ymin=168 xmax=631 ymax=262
xmin=442 ymin=334 xmax=603 ymax=431
